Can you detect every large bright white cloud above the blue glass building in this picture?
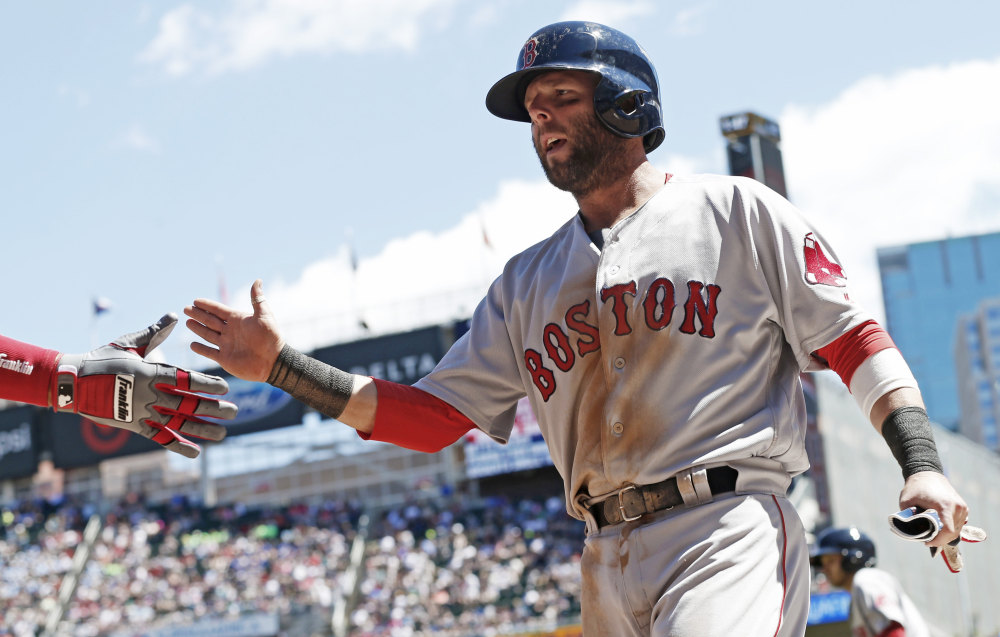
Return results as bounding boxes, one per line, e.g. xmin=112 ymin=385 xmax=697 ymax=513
xmin=780 ymin=59 xmax=1000 ymax=315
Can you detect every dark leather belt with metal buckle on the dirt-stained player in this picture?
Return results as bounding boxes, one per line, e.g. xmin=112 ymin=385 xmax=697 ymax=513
xmin=590 ymin=467 xmax=737 ymax=528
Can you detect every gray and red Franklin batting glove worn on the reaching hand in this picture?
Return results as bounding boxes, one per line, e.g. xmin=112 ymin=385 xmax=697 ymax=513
xmin=52 ymin=313 xmax=237 ymax=458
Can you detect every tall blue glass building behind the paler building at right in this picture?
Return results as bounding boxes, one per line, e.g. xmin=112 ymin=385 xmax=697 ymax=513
xmin=878 ymin=233 xmax=1000 ymax=431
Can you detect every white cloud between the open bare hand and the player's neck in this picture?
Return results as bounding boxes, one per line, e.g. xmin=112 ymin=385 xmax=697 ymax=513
xmin=258 ymin=176 xmax=576 ymax=349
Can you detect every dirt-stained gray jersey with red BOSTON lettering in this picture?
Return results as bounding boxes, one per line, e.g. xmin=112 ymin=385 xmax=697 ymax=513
xmin=417 ymin=175 xmax=871 ymax=519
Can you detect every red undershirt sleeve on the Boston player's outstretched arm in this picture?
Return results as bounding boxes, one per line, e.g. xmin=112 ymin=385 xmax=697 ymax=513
xmin=358 ymin=378 xmax=476 ymax=453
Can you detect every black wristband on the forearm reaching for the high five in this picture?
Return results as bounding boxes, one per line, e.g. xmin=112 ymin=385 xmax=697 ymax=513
xmin=267 ymin=345 xmax=354 ymax=418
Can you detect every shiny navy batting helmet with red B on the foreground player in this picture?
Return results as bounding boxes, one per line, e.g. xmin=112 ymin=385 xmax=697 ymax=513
xmin=486 ymin=22 xmax=665 ymax=153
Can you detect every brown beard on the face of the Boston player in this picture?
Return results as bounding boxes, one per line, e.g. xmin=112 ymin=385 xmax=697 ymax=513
xmin=532 ymin=113 xmax=631 ymax=197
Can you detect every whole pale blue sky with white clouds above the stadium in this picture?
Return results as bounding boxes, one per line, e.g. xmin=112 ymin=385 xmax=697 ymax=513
xmin=0 ymin=0 xmax=1000 ymax=368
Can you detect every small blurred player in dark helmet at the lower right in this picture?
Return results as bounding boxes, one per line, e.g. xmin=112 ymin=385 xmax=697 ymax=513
xmin=809 ymin=527 xmax=930 ymax=637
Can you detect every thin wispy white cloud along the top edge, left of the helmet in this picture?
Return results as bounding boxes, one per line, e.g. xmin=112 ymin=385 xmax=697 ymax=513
xmin=139 ymin=0 xmax=456 ymax=76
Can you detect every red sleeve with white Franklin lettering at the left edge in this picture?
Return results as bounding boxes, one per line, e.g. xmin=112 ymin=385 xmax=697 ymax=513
xmin=0 ymin=335 xmax=59 ymax=407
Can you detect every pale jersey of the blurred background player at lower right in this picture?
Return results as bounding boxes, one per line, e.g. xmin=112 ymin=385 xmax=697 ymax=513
xmin=851 ymin=568 xmax=930 ymax=637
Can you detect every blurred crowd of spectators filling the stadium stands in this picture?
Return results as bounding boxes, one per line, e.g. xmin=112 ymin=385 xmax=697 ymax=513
xmin=0 ymin=496 xmax=583 ymax=637
